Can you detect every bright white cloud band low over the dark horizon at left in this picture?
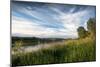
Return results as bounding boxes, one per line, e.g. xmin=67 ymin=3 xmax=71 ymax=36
xmin=12 ymin=15 xmax=71 ymax=38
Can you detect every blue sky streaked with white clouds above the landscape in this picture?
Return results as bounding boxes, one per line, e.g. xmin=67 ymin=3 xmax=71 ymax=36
xmin=11 ymin=1 xmax=96 ymax=38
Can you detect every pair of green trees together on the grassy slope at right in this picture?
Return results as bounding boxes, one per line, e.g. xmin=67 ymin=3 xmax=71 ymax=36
xmin=77 ymin=18 xmax=96 ymax=38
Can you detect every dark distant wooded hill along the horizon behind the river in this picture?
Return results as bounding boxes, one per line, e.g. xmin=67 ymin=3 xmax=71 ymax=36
xmin=12 ymin=37 xmax=65 ymax=45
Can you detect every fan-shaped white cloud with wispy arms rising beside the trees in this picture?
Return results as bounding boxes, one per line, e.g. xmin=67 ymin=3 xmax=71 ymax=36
xmin=48 ymin=7 xmax=95 ymax=38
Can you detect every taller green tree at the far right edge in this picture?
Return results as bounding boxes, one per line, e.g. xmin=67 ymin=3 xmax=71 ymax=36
xmin=87 ymin=18 xmax=96 ymax=33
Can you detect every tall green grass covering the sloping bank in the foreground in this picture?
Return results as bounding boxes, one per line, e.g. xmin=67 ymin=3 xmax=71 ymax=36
xmin=12 ymin=37 xmax=96 ymax=66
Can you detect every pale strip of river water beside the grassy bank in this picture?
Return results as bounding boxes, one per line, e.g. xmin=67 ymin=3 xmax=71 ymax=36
xmin=12 ymin=42 xmax=65 ymax=54
